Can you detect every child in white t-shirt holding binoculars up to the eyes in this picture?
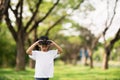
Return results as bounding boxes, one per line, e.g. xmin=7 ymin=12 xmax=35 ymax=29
xmin=26 ymin=36 xmax=62 ymax=80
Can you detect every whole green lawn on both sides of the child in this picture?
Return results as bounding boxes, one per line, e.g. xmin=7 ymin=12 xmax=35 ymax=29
xmin=0 ymin=64 xmax=120 ymax=80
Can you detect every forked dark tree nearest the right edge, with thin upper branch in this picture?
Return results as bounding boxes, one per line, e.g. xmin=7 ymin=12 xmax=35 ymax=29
xmin=103 ymin=0 xmax=120 ymax=69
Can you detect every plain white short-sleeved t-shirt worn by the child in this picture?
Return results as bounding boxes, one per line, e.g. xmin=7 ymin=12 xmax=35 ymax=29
xmin=29 ymin=50 xmax=58 ymax=78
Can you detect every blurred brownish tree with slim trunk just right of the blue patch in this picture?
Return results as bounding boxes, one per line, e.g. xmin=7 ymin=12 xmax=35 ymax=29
xmin=79 ymin=27 xmax=99 ymax=68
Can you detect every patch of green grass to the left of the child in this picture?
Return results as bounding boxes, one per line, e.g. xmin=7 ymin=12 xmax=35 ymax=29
xmin=0 ymin=69 xmax=34 ymax=80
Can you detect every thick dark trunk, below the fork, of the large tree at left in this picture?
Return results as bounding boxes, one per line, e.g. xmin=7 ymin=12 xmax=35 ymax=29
xmin=16 ymin=36 xmax=25 ymax=70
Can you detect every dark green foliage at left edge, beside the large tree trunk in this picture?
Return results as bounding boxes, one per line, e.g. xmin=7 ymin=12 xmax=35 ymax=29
xmin=0 ymin=24 xmax=16 ymax=67
